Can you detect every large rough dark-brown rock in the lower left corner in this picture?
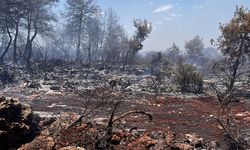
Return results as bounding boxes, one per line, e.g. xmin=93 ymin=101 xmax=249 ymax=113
xmin=0 ymin=97 xmax=40 ymax=149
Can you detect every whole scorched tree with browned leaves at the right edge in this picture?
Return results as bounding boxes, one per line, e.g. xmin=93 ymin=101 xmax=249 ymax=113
xmin=212 ymin=6 xmax=250 ymax=104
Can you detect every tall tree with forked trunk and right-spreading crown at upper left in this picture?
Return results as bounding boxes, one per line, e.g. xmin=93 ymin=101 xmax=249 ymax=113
xmin=24 ymin=0 xmax=58 ymax=71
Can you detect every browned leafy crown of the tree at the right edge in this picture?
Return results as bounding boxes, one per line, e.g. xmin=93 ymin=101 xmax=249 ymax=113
xmin=218 ymin=6 xmax=250 ymax=62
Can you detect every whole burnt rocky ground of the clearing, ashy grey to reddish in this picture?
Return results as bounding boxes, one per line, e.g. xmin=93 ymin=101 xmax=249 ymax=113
xmin=0 ymin=69 xmax=250 ymax=150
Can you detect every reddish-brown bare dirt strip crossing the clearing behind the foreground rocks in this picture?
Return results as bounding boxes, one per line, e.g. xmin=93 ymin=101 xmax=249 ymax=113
xmin=1 ymin=86 xmax=250 ymax=148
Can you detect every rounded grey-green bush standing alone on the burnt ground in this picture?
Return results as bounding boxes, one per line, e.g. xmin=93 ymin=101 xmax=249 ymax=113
xmin=175 ymin=64 xmax=203 ymax=93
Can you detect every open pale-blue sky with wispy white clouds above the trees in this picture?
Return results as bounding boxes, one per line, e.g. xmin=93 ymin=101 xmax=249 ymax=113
xmin=58 ymin=0 xmax=250 ymax=51
